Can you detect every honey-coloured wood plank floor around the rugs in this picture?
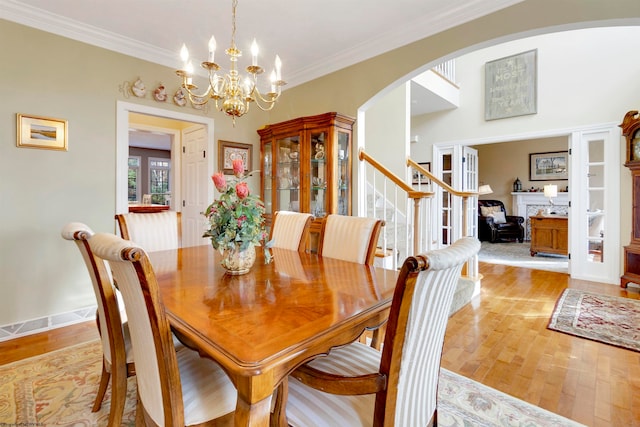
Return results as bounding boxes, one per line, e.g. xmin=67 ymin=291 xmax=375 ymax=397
xmin=0 ymin=263 xmax=640 ymax=426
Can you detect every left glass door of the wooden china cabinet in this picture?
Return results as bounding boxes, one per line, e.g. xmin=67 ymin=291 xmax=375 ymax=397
xmin=275 ymin=135 xmax=301 ymax=212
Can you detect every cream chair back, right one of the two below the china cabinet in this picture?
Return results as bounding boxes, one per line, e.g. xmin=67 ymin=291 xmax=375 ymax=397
xmin=318 ymin=214 xmax=383 ymax=265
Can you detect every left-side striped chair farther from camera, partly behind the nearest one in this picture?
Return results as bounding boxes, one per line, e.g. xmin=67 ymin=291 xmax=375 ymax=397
xmin=62 ymin=222 xmax=135 ymax=426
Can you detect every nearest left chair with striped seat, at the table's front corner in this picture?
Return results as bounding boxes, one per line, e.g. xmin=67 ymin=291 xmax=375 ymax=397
xmin=89 ymin=233 xmax=237 ymax=426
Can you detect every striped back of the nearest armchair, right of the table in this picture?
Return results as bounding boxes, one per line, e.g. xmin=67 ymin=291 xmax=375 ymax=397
xmin=374 ymin=237 xmax=480 ymax=426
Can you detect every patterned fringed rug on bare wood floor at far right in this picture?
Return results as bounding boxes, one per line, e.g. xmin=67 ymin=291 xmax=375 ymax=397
xmin=548 ymin=288 xmax=640 ymax=351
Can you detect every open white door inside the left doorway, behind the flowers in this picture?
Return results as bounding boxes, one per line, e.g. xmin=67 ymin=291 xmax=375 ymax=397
xmin=181 ymin=125 xmax=213 ymax=247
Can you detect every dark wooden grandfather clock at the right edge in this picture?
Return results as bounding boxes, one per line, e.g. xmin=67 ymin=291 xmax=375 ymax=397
xmin=620 ymin=111 xmax=640 ymax=288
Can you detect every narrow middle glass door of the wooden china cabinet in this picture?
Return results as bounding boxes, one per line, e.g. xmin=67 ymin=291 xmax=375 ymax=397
xmin=309 ymin=131 xmax=328 ymax=218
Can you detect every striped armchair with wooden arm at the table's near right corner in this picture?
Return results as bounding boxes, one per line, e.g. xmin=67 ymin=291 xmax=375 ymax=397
xmin=286 ymin=237 xmax=480 ymax=427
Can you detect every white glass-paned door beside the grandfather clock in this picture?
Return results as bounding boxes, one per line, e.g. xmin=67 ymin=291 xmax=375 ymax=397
xmin=569 ymin=127 xmax=622 ymax=284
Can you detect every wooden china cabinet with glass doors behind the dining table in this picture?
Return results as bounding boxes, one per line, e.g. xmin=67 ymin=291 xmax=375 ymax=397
xmin=258 ymin=113 xmax=354 ymax=242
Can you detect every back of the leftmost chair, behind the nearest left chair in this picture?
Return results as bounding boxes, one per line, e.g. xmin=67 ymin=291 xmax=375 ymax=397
xmin=61 ymin=222 xmax=127 ymax=378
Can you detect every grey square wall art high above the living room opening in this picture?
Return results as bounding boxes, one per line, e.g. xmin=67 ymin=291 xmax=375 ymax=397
xmin=484 ymin=49 xmax=538 ymax=120
